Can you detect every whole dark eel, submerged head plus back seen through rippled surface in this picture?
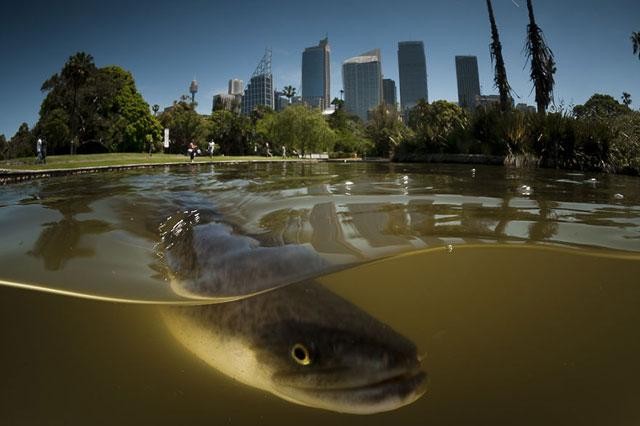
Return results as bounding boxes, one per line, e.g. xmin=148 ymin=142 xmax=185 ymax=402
xmin=162 ymin=211 xmax=426 ymax=414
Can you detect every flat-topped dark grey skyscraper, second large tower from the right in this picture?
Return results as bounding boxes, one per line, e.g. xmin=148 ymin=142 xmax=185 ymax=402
xmin=398 ymin=41 xmax=429 ymax=111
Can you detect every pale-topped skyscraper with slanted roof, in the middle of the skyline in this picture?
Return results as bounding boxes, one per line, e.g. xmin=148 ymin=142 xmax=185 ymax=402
xmin=342 ymin=49 xmax=382 ymax=121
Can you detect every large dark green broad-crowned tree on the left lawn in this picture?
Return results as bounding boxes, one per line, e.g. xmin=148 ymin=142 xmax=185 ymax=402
xmin=35 ymin=52 xmax=162 ymax=154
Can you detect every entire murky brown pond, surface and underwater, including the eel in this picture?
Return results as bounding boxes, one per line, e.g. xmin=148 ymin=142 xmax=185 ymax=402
xmin=0 ymin=164 xmax=640 ymax=425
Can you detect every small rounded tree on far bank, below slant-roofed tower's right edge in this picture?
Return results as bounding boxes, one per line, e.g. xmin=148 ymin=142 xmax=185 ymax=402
xmin=366 ymin=104 xmax=410 ymax=158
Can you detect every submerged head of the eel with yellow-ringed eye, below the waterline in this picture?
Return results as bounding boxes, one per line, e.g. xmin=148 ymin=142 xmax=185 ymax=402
xmin=163 ymin=282 xmax=426 ymax=414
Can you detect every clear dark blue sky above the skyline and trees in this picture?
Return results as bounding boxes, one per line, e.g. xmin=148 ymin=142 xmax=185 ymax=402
xmin=0 ymin=0 xmax=640 ymax=137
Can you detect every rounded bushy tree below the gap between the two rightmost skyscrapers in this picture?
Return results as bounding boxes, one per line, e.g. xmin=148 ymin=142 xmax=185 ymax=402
xmin=408 ymin=99 xmax=469 ymax=152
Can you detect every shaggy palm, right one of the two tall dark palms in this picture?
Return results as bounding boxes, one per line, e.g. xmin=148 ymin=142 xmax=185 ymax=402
xmin=525 ymin=0 xmax=556 ymax=114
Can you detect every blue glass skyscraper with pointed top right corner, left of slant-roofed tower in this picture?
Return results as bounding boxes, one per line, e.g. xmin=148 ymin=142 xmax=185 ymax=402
xmin=302 ymin=38 xmax=331 ymax=109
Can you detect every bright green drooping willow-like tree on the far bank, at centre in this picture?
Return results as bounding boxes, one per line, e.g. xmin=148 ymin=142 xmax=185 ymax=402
xmin=256 ymin=105 xmax=336 ymax=156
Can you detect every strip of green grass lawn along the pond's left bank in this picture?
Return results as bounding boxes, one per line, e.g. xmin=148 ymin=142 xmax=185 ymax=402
xmin=0 ymin=153 xmax=296 ymax=171
